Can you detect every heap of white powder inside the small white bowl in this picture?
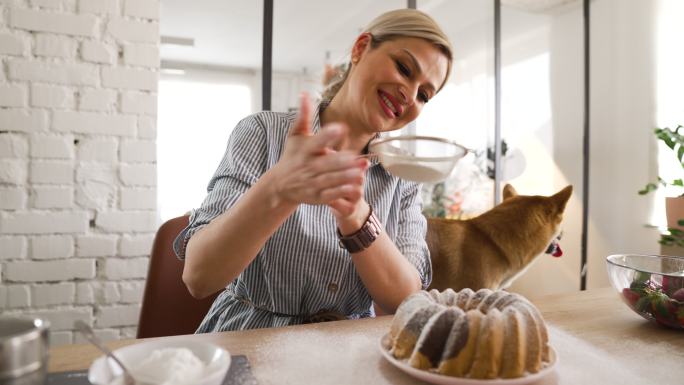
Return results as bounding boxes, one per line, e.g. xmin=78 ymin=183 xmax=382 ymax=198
xmin=109 ymin=348 xmax=206 ymax=385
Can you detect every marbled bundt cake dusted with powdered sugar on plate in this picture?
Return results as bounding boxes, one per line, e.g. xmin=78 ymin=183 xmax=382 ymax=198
xmin=390 ymin=289 xmax=549 ymax=379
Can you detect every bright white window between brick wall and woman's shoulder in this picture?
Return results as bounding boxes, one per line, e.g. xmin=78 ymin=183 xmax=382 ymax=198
xmin=157 ymin=78 xmax=252 ymax=222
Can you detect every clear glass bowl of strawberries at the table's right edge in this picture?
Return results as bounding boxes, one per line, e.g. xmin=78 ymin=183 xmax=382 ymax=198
xmin=606 ymin=254 xmax=684 ymax=330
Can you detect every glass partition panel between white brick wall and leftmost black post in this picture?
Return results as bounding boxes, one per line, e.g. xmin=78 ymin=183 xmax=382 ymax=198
xmin=157 ymin=0 xmax=263 ymax=220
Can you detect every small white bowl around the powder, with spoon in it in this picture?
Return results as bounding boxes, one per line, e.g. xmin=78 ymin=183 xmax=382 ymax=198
xmin=88 ymin=338 xmax=230 ymax=385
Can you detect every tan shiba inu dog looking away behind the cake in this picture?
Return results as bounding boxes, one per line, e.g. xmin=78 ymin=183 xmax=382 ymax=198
xmin=426 ymin=184 xmax=572 ymax=291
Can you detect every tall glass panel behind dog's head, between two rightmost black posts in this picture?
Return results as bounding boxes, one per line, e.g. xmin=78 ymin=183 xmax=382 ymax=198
xmin=501 ymin=2 xmax=584 ymax=295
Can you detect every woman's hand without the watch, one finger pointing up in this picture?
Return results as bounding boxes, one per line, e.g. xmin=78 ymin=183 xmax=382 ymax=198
xmin=273 ymin=94 xmax=368 ymax=205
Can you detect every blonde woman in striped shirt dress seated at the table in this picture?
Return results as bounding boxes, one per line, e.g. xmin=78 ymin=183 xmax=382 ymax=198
xmin=176 ymin=9 xmax=452 ymax=333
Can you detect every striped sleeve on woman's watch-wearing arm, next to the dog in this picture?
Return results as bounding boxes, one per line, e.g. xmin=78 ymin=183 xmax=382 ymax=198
xmin=395 ymin=181 xmax=432 ymax=289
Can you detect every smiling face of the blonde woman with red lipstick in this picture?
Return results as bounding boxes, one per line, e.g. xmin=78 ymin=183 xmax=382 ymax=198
xmin=344 ymin=34 xmax=449 ymax=134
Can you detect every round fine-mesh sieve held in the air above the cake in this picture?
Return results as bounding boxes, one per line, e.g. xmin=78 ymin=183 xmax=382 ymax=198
xmin=368 ymin=135 xmax=471 ymax=183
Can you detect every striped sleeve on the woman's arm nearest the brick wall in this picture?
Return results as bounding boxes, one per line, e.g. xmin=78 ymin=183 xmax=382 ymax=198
xmin=173 ymin=115 xmax=268 ymax=259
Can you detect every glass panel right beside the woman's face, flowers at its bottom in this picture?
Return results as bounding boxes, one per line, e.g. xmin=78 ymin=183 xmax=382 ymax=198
xmin=420 ymin=0 xmax=494 ymax=217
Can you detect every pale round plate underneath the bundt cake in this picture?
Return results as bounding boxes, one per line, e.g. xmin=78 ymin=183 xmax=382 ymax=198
xmin=380 ymin=334 xmax=558 ymax=385
